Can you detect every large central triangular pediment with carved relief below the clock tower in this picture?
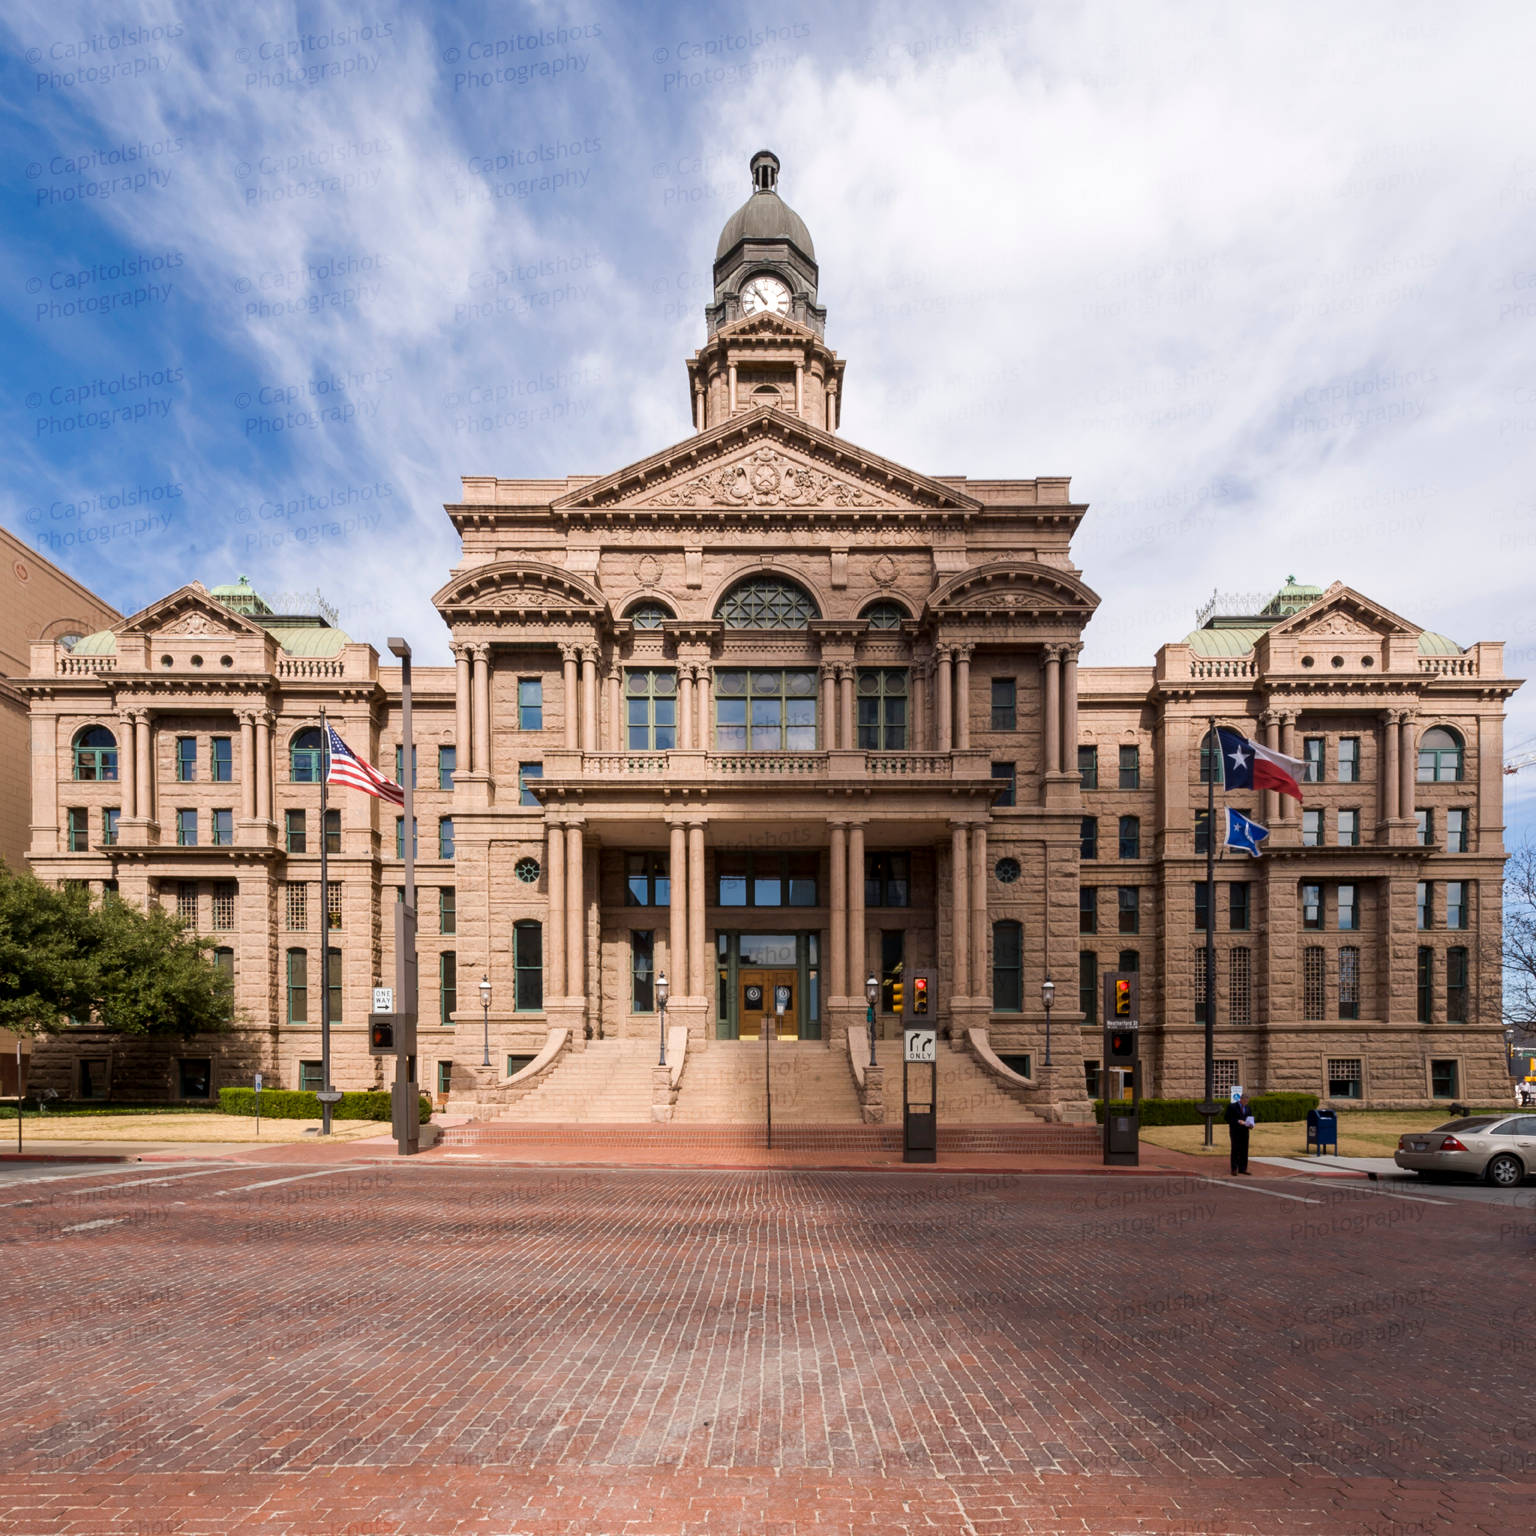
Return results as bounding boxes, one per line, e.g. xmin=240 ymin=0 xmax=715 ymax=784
xmin=554 ymin=407 xmax=980 ymax=511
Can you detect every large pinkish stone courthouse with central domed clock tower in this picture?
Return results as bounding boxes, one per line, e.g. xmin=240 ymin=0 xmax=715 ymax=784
xmin=17 ymin=154 xmax=1516 ymax=1120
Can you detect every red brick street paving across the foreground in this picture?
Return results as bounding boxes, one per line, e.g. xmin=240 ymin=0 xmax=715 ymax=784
xmin=0 ymin=1157 xmax=1536 ymax=1536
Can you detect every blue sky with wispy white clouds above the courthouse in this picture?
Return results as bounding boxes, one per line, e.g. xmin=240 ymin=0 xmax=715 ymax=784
xmin=0 ymin=0 xmax=1536 ymax=841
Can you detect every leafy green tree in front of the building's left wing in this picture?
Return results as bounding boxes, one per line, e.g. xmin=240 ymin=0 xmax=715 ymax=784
xmin=0 ymin=863 xmax=233 ymax=1035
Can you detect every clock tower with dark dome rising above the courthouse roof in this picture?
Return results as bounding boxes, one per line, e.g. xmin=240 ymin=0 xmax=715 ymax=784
xmin=688 ymin=149 xmax=843 ymax=432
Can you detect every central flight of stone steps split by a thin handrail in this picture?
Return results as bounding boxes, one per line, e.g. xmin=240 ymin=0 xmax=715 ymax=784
xmin=673 ymin=1040 xmax=863 ymax=1126
